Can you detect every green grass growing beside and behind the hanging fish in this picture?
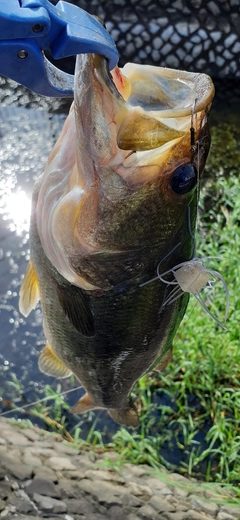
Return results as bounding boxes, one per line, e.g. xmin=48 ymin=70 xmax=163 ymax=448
xmin=0 ymin=117 xmax=240 ymax=490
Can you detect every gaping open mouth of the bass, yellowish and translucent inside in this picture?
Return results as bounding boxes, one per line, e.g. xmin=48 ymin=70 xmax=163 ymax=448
xmin=111 ymin=63 xmax=214 ymax=151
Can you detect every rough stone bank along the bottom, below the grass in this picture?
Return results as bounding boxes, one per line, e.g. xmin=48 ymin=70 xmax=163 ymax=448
xmin=0 ymin=418 xmax=240 ymax=520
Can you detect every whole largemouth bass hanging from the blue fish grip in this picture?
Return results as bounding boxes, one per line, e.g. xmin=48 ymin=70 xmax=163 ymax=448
xmin=20 ymin=55 xmax=214 ymax=426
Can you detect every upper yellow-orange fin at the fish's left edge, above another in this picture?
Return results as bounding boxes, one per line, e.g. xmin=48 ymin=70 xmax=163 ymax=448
xmin=19 ymin=260 xmax=39 ymax=317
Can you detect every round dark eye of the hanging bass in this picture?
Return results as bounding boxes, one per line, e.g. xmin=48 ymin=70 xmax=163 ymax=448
xmin=170 ymin=164 xmax=197 ymax=195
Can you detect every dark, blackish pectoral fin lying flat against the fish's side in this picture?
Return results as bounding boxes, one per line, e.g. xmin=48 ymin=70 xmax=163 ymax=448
xmin=57 ymin=285 xmax=95 ymax=336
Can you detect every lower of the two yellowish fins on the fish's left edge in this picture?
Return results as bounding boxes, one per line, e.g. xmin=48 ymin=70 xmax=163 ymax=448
xmin=38 ymin=343 xmax=72 ymax=379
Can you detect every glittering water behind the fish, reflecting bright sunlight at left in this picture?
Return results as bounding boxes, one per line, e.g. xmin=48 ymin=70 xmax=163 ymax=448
xmin=0 ymin=73 xmax=240 ymax=476
